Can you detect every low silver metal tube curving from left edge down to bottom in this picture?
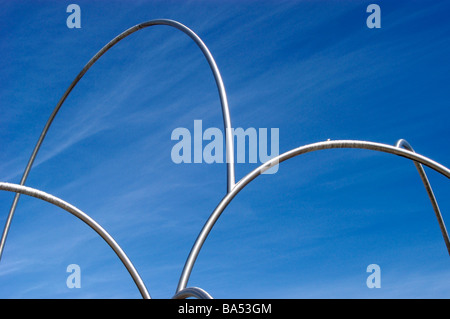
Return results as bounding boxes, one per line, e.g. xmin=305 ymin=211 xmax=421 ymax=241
xmin=0 ymin=182 xmax=150 ymax=299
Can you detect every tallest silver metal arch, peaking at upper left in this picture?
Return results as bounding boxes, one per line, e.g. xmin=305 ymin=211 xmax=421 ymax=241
xmin=0 ymin=19 xmax=235 ymax=259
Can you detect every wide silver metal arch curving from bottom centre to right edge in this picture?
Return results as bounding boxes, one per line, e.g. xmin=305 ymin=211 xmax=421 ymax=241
xmin=177 ymin=140 xmax=450 ymax=292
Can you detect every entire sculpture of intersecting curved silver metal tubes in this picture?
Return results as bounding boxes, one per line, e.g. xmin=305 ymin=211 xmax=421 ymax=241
xmin=0 ymin=19 xmax=450 ymax=299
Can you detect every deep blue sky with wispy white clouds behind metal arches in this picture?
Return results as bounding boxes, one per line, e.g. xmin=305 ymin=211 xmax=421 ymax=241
xmin=0 ymin=1 xmax=450 ymax=298
